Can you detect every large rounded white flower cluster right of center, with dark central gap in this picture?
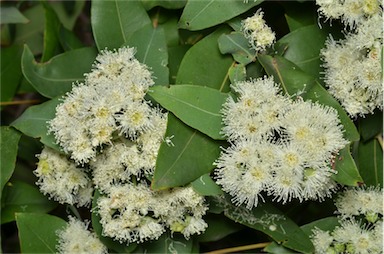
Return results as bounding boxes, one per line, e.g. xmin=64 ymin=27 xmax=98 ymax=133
xmin=215 ymin=77 xmax=347 ymax=209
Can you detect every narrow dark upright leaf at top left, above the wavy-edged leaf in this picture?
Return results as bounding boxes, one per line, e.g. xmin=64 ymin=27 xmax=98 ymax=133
xmin=41 ymin=2 xmax=61 ymax=62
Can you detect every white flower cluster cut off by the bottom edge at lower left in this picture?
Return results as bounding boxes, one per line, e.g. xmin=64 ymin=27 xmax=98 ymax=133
xmin=56 ymin=217 xmax=108 ymax=254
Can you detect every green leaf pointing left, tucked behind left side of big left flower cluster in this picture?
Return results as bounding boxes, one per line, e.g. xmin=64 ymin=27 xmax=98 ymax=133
xmin=11 ymin=98 xmax=60 ymax=151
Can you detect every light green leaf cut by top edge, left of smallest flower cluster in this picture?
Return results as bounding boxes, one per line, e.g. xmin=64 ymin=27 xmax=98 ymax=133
xmin=179 ymin=0 xmax=262 ymax=31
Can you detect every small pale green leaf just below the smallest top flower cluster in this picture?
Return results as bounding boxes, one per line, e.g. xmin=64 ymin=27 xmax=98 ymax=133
xmin=218 ymin=32 xmax=256 ymax=65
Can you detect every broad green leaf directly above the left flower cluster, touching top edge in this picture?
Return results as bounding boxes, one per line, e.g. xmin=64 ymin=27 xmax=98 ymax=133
xmin=91 ymin=0 xmax=151 ymax=50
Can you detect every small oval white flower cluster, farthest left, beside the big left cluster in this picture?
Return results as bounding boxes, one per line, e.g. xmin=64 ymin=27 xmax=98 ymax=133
xmin=34 ymin=147 xmax=93 ymax=207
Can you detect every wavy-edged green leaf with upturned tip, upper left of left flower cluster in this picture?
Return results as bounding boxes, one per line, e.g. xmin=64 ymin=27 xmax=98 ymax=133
xmin=21 ymin=46 xmax=96 ymax=98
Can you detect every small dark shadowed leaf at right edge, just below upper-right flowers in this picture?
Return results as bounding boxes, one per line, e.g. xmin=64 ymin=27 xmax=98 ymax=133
xmin=359 ymin=110 xmax=383 ymax=142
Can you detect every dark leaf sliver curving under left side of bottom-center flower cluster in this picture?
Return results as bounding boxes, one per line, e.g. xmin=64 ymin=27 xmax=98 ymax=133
xmin=91 ymin=190 xmax=137 ymax=253
